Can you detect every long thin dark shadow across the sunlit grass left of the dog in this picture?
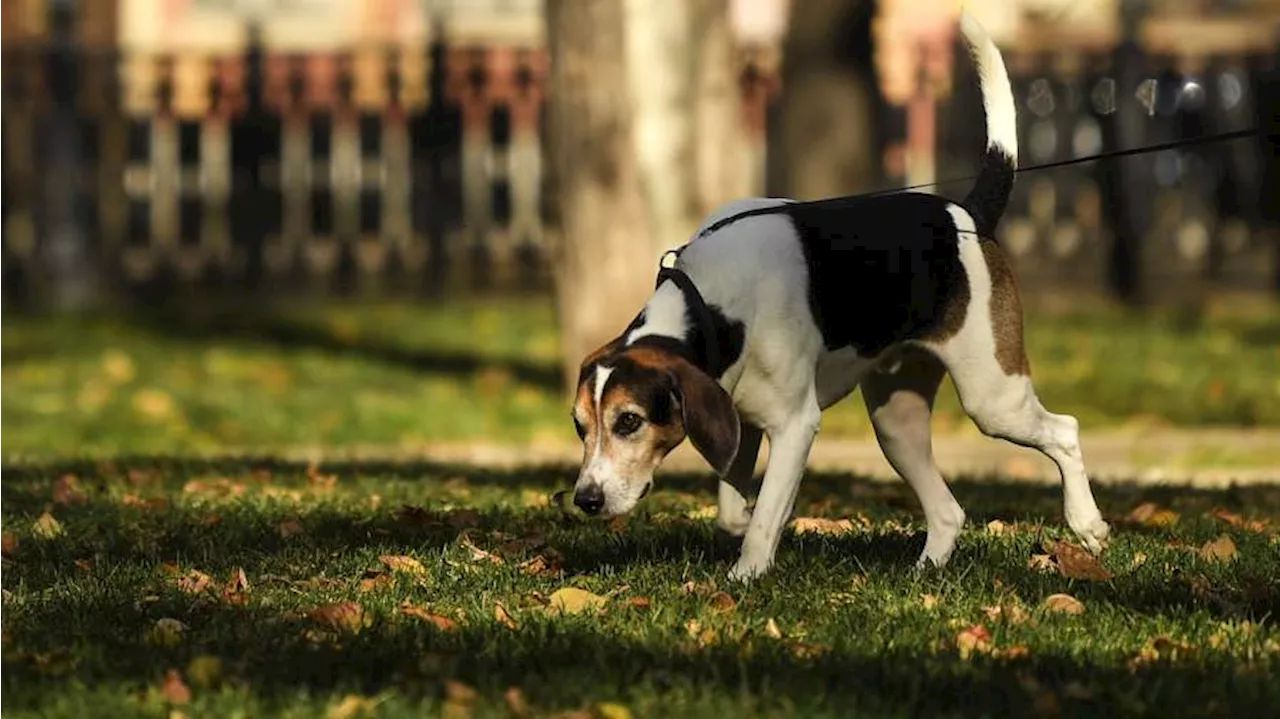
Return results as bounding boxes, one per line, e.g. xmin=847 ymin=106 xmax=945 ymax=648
xmin=116 ymin=307 xmax=563 ymax=391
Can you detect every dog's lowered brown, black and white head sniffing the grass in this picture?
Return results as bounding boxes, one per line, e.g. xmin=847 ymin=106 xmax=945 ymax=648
xmin=573 ymin=342 xmax=740 ymax=517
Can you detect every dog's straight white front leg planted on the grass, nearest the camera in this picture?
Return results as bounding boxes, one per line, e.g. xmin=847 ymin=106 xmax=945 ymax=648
xmin=728 ymin=397 xmax=822 ymax=581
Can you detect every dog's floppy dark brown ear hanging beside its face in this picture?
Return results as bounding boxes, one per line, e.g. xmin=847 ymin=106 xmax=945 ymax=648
xmin=671 ymin=360 xmax=741 ymax=477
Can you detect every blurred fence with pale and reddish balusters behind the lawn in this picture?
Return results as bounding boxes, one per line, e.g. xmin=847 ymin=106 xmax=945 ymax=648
xmin=0 ymin=12 xmax=1280 ymax=307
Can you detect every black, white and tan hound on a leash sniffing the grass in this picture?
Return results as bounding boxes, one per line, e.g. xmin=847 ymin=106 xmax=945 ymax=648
xmin=573 ymin=14 xmax=1110 ymax=581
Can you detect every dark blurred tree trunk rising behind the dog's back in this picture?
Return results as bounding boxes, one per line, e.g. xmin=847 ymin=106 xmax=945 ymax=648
xmin=769 ymin=0 xmax=878 ymax=200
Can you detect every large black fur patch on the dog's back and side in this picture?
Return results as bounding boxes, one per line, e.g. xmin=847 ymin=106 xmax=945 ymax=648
xmin=781 ymin=193 xmax=966 ymax=356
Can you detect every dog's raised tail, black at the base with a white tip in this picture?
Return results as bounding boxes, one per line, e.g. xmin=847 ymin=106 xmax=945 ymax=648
xmin=960 ymin=10 xmax=1018 ymax=237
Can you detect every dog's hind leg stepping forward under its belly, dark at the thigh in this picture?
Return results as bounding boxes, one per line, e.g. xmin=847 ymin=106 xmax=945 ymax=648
xmin=863 ymin=349 xmax=965 ymax=567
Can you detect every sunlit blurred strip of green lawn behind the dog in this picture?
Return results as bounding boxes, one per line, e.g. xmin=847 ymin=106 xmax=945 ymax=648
xmin=0 ymin=299 xmax=1280 ymax=458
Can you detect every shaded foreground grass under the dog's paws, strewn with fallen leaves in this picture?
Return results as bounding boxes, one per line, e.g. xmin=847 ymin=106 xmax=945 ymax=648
xmin=0 ymin=459 xmax=1280 ymax=718
